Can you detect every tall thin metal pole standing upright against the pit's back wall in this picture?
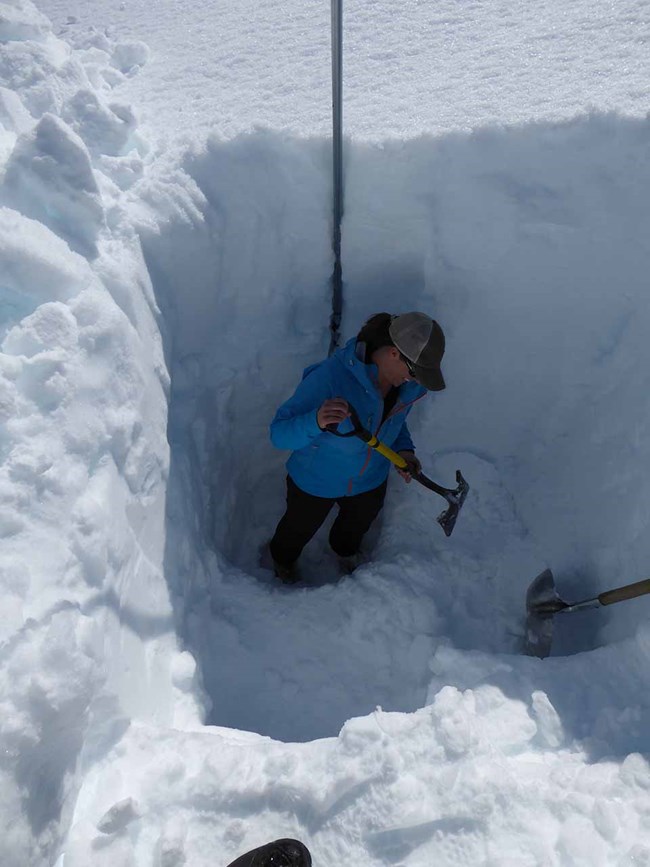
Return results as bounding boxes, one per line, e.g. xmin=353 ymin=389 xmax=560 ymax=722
xmin=329 ymin=0 xmax=343 ymax=355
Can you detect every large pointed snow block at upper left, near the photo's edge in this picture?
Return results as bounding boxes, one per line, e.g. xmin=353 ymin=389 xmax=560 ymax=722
xmin=2 ymin=114 xmax=104 ymax=258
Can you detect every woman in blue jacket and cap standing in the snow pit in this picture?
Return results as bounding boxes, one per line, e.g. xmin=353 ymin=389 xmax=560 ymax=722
xmin=269 ymin=313 xmax=445 ymax=584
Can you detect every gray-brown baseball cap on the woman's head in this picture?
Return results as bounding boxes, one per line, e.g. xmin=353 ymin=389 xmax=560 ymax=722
xmin=388 ymin=313 xmax=446 ymax=391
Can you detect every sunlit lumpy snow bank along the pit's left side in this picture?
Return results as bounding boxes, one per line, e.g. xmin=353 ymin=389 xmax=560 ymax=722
xmin=0 ymin=3 xmax=196 ymax=867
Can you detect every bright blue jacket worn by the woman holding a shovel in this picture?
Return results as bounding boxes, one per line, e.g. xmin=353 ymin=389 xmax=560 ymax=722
xmin=271 ymin=338 xmax=427 ymax=498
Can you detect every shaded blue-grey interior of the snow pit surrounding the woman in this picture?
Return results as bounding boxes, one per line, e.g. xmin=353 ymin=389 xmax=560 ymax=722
xmin=137 ymin=115 xmax=650 ymax=740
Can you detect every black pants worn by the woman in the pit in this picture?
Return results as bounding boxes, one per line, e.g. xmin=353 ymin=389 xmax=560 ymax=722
xmin=269 ymin=476 xmax=388 ymax=566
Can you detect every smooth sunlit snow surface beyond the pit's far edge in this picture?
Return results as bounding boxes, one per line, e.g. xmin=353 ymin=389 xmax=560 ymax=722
xmin=40 ymin=0 xmax=650 ymax=147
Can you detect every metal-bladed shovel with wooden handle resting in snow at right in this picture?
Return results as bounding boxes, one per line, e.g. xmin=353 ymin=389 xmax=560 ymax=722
xmin=526 ymin=569 xmax=650 ymax=659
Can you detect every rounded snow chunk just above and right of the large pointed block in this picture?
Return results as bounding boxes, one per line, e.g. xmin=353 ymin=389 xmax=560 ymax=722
xmin=62 ymin=89 xmax=136 ymax=156
